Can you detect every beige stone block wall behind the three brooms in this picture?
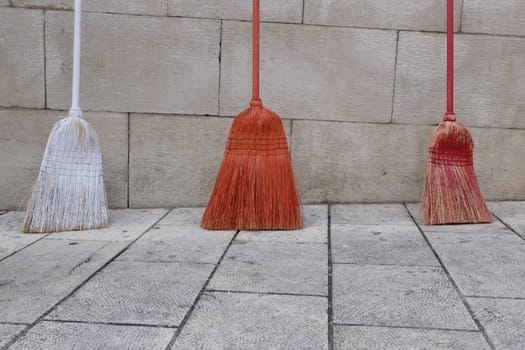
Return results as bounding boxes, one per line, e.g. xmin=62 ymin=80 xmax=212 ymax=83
xmin=0 ymin=0 xmax=525 ymax=209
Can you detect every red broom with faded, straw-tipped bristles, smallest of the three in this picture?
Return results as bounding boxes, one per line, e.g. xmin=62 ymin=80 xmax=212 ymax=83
xmin=422 ymin=0 xmax=493 ymax=225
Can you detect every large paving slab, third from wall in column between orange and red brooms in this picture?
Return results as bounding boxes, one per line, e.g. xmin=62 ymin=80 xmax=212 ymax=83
xmin=333 ymin=264 xmax=477 ymax=330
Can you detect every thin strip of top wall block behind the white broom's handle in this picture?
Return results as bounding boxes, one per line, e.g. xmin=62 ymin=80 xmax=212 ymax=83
xmin=12 ymin=0 xmax=166 ymax=16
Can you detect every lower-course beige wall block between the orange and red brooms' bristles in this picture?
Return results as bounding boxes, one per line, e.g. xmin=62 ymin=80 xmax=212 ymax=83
xmin=292 ymin=121 xmax=431 ymax=204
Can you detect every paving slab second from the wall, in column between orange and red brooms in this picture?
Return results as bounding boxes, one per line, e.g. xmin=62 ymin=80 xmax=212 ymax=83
xmin=331 ymin=224 xmax=440 ymax=266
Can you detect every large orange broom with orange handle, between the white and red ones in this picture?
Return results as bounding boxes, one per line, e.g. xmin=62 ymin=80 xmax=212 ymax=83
xmin=201 ymin=0 xmax=303 ymax=230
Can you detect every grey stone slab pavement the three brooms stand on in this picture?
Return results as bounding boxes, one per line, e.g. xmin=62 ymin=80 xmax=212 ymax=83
xmin=0 ymin=202 xmax=525 ymax=350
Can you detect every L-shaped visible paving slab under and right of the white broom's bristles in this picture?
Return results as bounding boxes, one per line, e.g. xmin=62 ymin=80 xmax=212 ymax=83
xmin=46 ymin=209 xmax=168 ymax=241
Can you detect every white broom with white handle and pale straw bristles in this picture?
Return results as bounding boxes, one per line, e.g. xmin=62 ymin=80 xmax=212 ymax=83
xmin=22 ymin=0 xmax=108 ymax=233
